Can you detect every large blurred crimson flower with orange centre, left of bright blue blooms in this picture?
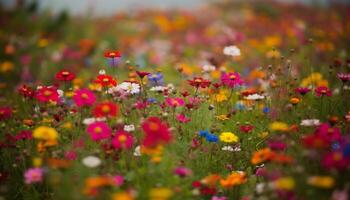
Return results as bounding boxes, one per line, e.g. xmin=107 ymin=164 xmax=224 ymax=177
xmin=141 ymin=117 xmax=172 ymax=147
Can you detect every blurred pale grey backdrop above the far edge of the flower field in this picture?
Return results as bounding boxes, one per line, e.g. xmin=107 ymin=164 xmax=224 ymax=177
xmin=0 ymin=0 xmax=350 ymax=16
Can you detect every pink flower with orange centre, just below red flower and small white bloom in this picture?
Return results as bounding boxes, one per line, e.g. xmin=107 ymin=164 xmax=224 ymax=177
xmin=87 ymin=122 xmax=111 ymax=141
